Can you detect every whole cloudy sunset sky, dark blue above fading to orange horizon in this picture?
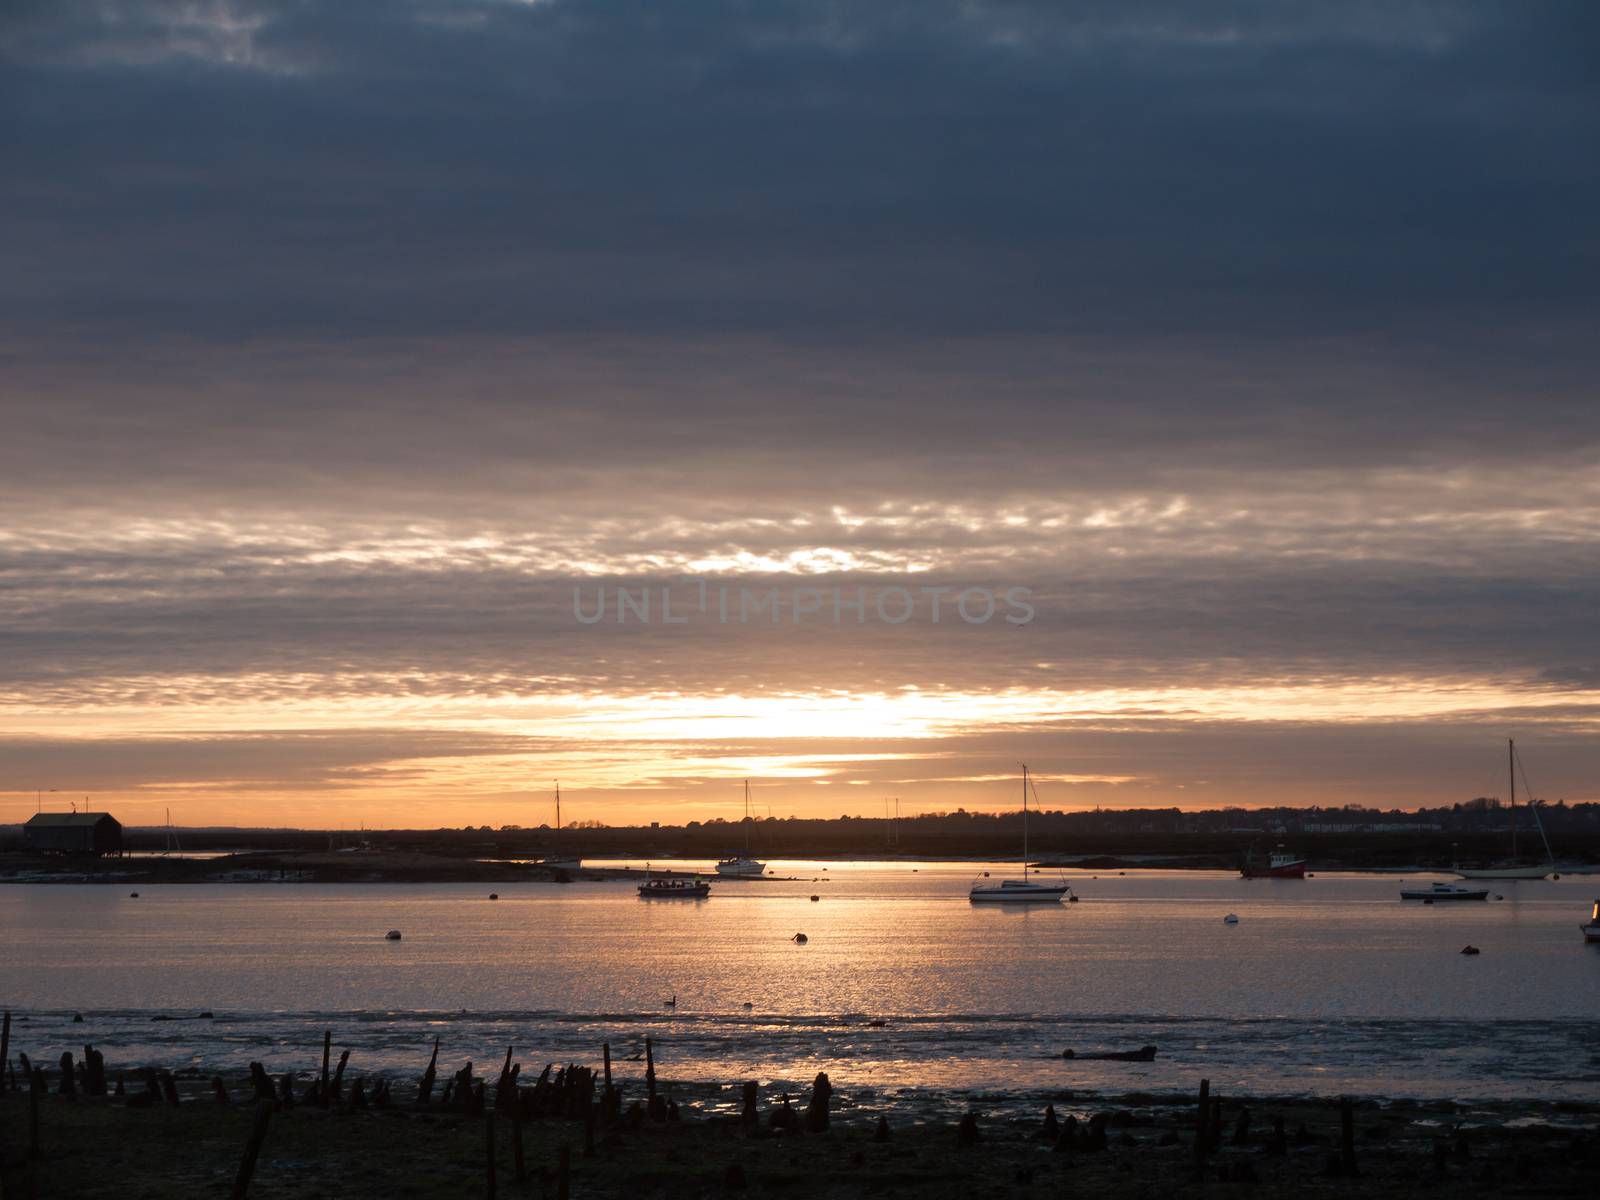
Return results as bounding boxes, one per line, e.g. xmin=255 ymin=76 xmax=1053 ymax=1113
xmin=0 ymin=0 xmax=1600 ymax=827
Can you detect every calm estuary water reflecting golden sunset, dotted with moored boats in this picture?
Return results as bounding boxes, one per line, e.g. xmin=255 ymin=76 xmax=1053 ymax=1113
xmin=0 ymin=861 xmax=1600 ymax=1104
